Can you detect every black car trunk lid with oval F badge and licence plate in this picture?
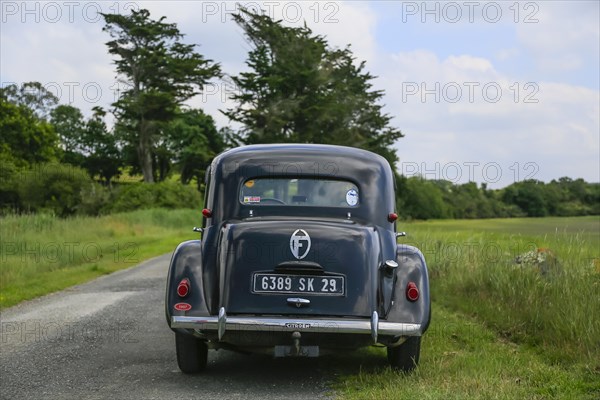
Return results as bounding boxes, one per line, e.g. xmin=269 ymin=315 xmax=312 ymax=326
xmin=219 ymin=220 xmax=379 ymax=317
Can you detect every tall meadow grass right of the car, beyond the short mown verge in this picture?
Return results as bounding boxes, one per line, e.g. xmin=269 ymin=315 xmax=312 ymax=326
xmin=401 ymin=217 xmax=600 ymax=368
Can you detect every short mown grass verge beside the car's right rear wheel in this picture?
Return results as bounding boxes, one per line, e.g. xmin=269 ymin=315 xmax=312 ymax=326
xmin=330 ymin=303 xmax=600 ymax=400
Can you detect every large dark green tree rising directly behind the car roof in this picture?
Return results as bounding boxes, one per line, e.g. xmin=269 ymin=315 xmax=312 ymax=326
xmin=224 ymin=9 xmax=402 ymax=164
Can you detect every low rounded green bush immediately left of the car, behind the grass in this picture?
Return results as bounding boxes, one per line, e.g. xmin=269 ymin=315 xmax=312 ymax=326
xmin=108 ymin=182 xmax=202 ymax=212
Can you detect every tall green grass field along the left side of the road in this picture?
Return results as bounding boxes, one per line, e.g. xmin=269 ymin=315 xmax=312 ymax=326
xmin=0 ymin=209 xmax=201 ymax=308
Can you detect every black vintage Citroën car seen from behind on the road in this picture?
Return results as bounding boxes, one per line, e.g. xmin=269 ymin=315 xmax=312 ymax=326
xmin=166 ymin=144 xmax=430 ymax=373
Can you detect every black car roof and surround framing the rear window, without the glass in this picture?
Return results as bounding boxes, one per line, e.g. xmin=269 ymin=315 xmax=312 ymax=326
xmin=208 ymin=144 xmax=395 ymax=225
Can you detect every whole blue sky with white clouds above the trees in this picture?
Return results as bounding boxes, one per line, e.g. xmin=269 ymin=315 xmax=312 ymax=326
xmin=0 ymin=0 xmax=600 ymax=188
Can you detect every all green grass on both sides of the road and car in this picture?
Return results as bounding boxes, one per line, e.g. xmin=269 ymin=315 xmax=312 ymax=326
xmin=0 ymin=210 xmax=600 ymax=399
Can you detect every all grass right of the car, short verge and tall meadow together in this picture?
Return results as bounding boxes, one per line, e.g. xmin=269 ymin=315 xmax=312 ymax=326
xmin=335 ymin=217 xmax=600 ymax=399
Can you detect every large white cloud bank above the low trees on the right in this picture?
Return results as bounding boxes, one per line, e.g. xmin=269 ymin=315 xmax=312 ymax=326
xmin=381 ymin=50 xmax=600 ymax=186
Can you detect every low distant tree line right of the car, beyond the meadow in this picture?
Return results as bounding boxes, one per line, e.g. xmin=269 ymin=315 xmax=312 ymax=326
xmin=396 ymin=176 xmax=600 ymax=219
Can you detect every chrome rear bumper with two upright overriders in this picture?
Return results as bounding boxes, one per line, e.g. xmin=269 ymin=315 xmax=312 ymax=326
xmin=171 ymin=307 xmax=422 ymax=343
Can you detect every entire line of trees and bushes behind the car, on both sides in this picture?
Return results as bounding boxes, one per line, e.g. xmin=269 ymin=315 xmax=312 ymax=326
xmin=0 ymin=9 xmax=600 ymax=219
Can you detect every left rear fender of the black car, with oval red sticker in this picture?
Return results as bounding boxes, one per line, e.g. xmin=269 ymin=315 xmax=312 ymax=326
xmin=165 ymin=240 xmax=210 ymax=326
